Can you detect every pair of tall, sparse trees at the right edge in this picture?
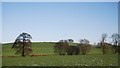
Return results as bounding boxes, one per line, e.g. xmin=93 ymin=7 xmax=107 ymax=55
xmin=98 ymin=33 xmax=120 ymax=54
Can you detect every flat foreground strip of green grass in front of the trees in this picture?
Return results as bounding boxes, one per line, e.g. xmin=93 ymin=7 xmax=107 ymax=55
xmin=3 ymin=55 xmax=118 ymax=66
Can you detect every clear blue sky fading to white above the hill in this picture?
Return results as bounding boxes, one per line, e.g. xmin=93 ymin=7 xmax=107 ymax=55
xmin=2 ymin=2 xmax=118 ymax=43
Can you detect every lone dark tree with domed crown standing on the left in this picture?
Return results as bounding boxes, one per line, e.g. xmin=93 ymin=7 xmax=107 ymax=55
xmin=12 ymin=32 xmax=32 ymax=57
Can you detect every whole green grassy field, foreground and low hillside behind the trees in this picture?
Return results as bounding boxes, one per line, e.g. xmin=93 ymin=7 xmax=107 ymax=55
xmin=2 ymin=42 xmax=118 ymax=66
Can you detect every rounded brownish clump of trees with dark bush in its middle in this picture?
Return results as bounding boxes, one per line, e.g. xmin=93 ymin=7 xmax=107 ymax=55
xmin=54 ymin=39 xmax=91 ymax=55
